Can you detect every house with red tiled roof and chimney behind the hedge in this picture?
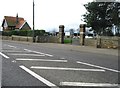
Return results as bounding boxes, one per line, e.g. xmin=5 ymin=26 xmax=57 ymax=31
xmin=2 ymin=14 xmax=31 ymax=31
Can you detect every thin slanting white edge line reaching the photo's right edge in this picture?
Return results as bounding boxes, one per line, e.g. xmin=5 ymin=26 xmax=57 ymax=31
xmin=77 ymin=61 xmax=120 ymax=73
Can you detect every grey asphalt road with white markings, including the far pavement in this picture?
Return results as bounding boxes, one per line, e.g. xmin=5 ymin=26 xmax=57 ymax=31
xmin=0 ymin=40 xmax=120 ymax=88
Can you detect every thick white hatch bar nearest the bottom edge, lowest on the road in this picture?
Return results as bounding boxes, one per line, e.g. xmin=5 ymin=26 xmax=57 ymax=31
xmin=60 ymin=82 xmax=118 ymax=87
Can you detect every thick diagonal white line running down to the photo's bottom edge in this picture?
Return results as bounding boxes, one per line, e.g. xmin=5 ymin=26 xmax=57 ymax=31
xmin=19 ymin=65 xmax=58 ymax=88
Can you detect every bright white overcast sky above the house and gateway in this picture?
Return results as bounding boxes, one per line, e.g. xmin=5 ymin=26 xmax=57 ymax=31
xmin=0 ymin=0 xmax=93 ymax=32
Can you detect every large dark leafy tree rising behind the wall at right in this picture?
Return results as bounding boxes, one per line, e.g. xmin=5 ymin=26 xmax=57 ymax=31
xmin=83 ymin=2 xmax=120 ymax=35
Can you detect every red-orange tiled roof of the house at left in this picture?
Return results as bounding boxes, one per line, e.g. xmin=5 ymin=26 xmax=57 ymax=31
xmin=5 ymin=16 xmax=25 ymax=28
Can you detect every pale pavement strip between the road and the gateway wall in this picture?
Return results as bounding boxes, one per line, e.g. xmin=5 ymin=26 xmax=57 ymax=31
xmin=35 ymin=43 xmax=118 ymax=56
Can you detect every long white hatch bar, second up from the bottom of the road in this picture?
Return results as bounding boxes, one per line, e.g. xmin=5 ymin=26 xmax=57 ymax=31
xmin=30 ymin=66 xmax=105 ymax=72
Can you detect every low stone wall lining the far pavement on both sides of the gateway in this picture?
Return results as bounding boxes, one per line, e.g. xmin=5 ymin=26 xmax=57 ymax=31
xmin=2 ymin=36 xmax=120 ymax=49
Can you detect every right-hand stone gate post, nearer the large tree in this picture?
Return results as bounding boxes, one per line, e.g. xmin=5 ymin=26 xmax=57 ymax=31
xmin=80 ymin=24 xmax=85 ymax=45
